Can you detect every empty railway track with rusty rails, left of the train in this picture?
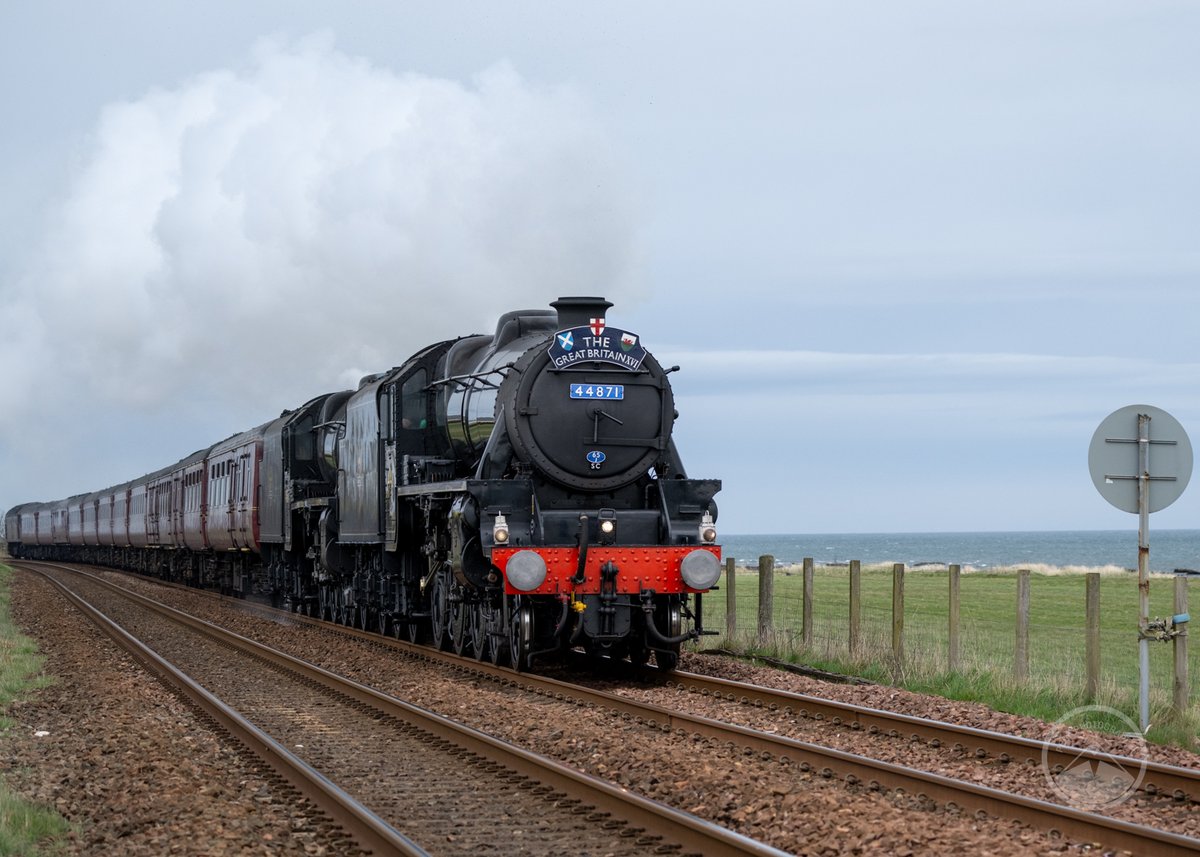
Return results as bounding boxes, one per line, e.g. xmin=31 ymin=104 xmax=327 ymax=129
xmin=22 ymin=564 xmax=784 ymax=856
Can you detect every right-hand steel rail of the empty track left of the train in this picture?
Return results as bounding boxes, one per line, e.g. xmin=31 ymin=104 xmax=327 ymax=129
xmin=28 ymin=570 xmax=786 ymax=857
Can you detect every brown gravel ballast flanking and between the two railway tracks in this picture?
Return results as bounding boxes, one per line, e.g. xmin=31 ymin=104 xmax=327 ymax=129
xmin=0 ymin=564 xmax=1195 ymax=855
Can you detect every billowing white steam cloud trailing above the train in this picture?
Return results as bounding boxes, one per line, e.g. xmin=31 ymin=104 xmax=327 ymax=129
xmin=0 ymin=36 xmax=634 ymax=502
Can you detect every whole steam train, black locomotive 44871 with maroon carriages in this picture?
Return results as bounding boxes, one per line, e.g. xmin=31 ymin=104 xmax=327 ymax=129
xmin=5 ymin=296 xmax=721 ymax=670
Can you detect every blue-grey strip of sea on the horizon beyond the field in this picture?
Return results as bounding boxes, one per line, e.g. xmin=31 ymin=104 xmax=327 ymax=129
xmin=721 ymin=529 xmax=1200 ymax=573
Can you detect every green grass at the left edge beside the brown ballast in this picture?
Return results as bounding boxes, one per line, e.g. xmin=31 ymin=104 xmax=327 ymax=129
xmin=0 ymin=564 xmax=70 ymax=856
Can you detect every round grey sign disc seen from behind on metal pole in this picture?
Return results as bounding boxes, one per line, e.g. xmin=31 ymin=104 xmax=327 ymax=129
xmin=1087 ymin=404 xmax=1192 ymax=515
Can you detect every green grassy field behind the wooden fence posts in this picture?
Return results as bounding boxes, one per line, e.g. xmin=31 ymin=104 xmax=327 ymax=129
xmin=702 ymin=565 xmax=1200 ymax=747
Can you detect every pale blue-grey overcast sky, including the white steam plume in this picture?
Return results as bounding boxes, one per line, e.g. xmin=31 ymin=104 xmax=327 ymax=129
xmin=0 ymin=0 xmax=1200 ymax=532
